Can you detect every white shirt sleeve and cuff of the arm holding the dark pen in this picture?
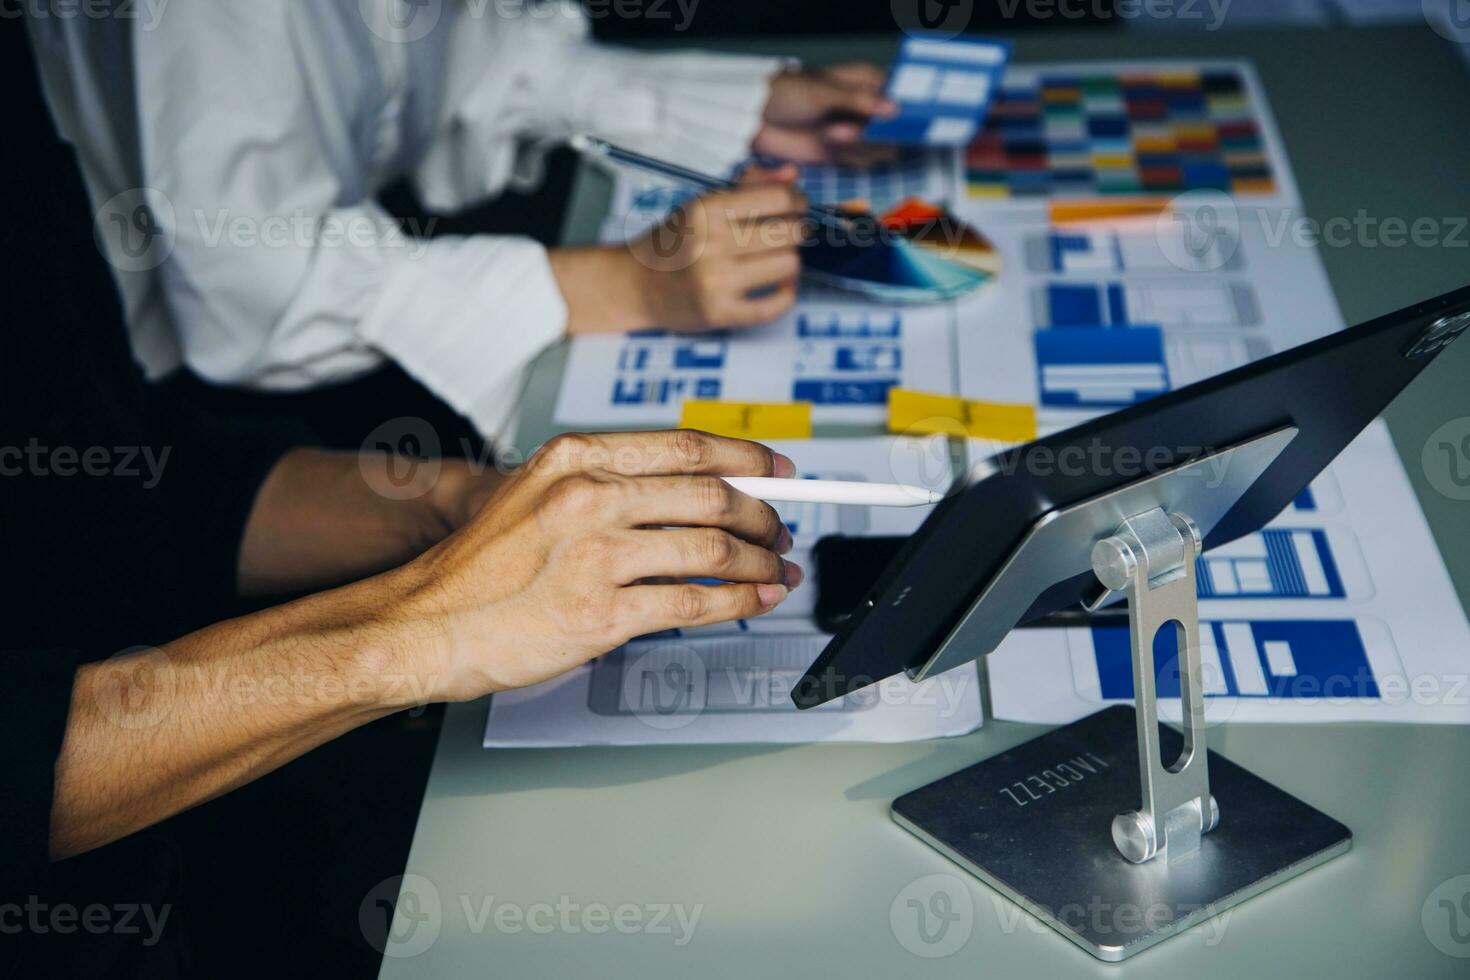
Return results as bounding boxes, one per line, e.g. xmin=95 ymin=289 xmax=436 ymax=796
xmin=135 ymin=0 xmax=566 ymax=433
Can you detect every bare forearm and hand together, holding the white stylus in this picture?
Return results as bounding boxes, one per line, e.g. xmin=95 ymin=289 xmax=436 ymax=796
xmin=51 ymin=430 xmax=801 ymax=858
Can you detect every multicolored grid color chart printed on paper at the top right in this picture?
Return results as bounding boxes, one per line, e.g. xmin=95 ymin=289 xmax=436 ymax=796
xmin=964 ymin=68 xmax=1277 ymax=198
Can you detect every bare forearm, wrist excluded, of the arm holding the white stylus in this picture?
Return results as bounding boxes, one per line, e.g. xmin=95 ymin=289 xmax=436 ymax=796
xmin=51 ymin=576 xmax=431 ymax=860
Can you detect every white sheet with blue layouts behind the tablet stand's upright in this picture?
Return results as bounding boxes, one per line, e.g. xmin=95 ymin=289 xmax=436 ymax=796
xmin=989 ymin=422 xmax=1470 ymax=724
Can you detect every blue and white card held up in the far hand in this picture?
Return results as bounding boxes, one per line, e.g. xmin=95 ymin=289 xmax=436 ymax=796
xmin=863 ymin=37 xmax=1010 ymax=147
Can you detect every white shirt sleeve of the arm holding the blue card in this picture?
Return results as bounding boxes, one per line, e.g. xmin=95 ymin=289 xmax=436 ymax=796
xmin=416 ymin=1 xmax=791 ymax=207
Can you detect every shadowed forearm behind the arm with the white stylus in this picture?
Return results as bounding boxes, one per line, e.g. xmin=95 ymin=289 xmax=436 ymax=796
xmin=240 ymin=450 xmax=500 ymax=595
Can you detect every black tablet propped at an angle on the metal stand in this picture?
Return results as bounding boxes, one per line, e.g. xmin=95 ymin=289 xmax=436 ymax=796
xmin=792 ymin=287 xmax=1470 ymax=708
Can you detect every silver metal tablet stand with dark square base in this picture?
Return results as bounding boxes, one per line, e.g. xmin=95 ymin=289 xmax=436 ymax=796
xmin=894 ymin=428 xmax=1352 ymax=961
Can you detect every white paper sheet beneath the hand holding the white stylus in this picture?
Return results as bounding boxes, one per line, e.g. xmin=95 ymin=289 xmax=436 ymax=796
xmin=485 ymin=436 xmax=982 ymax=748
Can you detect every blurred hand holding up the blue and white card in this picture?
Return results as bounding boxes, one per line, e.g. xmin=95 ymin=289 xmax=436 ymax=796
xmin=751 ymin=63 xmax=898 ymax=165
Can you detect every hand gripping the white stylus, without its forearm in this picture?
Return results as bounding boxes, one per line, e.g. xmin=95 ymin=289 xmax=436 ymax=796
xmin=390 ymin=430 xmax=803 ymax=699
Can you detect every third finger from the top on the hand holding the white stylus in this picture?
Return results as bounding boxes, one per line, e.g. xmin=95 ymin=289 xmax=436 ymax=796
xmin=613 ymin=527 xmax=801 ymax=588
